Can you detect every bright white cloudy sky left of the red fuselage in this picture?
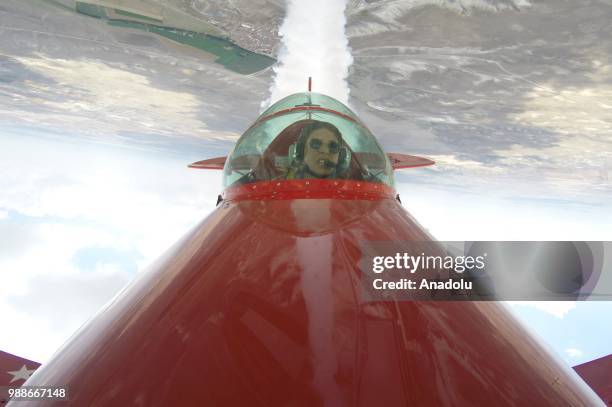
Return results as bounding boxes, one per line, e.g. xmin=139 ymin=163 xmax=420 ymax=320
xmin=0 ymin=131 xmax=221 ymax=362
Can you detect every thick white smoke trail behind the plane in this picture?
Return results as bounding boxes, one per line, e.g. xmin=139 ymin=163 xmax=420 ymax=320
xmin=262 ymin=0 xmax=353 ymax=108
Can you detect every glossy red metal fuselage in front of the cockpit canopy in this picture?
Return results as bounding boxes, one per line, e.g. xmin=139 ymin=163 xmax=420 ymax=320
xmin=15 ymin=199 xmax=601 ymax=406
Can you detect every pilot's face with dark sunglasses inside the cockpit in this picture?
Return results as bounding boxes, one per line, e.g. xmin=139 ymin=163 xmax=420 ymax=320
xmin=304 ymin=128 xmax=340 ymax=178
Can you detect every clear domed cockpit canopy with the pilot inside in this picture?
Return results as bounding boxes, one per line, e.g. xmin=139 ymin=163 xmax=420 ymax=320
xmin=224 ymin=93 xmax=393 ymax=187
